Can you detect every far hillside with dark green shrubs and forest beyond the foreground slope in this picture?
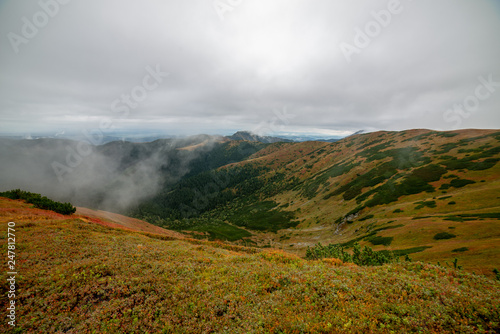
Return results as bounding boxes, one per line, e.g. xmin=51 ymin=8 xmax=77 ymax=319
xmin=132 ymin=130 xmax=500 ymax=274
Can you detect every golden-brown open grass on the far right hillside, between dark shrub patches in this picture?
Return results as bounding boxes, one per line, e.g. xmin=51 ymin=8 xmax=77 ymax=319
xmin=220 ymin=130 xmax=500 ymax=275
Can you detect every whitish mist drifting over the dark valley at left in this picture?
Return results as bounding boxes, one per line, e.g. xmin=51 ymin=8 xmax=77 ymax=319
xmin=0 ymin=137 xmax=218 ymax=212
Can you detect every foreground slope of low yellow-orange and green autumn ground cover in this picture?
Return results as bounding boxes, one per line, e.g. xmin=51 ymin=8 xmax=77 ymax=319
xmin=0 ymin=200 xmax=500 ymax=333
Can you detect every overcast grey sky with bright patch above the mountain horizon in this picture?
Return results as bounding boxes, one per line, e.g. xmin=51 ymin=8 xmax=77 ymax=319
xmin=0 ymin=0 xmax=500 ymax=135
